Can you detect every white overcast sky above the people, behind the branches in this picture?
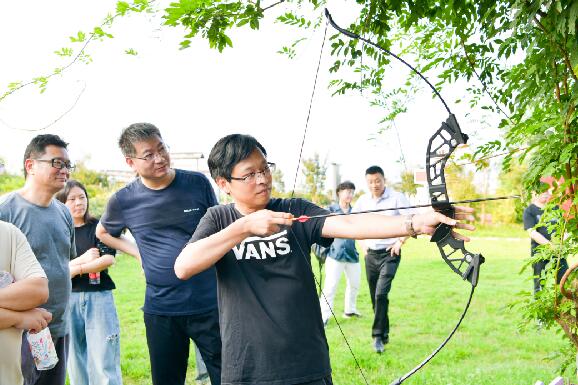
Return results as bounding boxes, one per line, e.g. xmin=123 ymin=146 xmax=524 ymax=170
xmin=0 ymin=0 xmax=497 ymax=189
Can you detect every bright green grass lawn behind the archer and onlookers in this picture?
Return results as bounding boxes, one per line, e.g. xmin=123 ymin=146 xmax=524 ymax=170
xmin=112 ymin=234 xmax=564 ymax=385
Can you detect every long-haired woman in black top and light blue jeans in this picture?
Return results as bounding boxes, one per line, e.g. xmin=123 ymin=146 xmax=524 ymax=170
xmin=56 ymin=180 xmax=122 ymax=385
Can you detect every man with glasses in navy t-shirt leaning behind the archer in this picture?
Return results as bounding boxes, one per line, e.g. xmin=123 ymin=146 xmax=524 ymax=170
xmin=96 ymin=123 xmax=221 ymax=385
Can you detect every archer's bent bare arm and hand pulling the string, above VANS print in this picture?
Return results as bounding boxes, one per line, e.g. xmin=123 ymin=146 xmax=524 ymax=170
xmin=175 ymin=210 xmax=293 ymax=279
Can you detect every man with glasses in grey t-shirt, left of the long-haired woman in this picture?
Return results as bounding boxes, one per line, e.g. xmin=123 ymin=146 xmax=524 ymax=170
xmin=0 ymin=134 xmax=76 ymax=385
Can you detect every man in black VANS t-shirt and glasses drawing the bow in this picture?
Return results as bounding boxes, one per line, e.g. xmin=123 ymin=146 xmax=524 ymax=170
xmin=175 ymin=134 xmax=473 ymax=385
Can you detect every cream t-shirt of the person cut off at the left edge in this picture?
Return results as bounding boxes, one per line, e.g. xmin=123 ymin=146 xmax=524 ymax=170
xmin=0 ymin=221 xmax=46 ymax=385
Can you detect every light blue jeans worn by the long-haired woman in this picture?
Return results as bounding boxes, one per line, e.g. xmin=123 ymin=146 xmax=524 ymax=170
xmin=68 ymin=290 xmax=122 ymax=385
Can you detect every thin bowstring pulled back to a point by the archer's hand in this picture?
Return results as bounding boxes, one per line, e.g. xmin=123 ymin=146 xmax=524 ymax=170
xmin=288 ymin=20 xmax=369 ymax=385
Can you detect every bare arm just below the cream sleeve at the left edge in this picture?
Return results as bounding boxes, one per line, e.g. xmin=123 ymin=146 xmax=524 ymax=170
xmin=0 ymin=277 xmax=48 ymax=311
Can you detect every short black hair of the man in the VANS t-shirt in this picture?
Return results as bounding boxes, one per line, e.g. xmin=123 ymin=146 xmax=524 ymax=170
xmin=207 ymin=134 xmax=267 ymax=182
